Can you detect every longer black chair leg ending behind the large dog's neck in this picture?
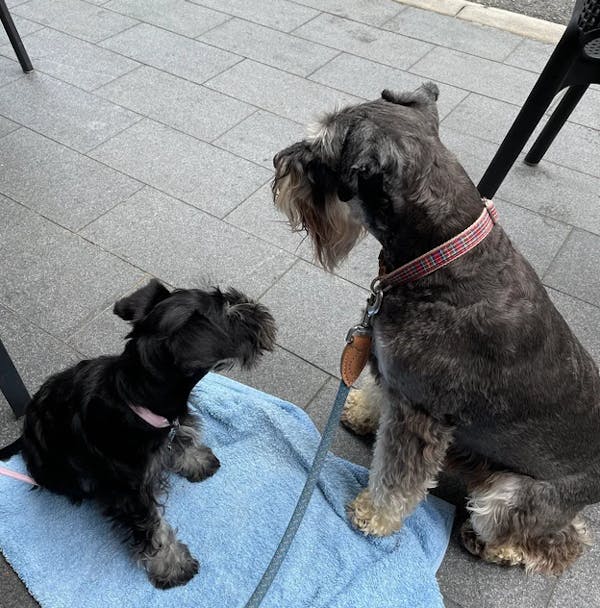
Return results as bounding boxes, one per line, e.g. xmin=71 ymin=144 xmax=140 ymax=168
xmin=477 ymin=31 xmax=577 ymax=198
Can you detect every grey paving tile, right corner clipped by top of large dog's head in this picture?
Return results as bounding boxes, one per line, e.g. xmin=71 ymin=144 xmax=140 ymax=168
xmin=206 ymin=59 xmax=361 ymax=124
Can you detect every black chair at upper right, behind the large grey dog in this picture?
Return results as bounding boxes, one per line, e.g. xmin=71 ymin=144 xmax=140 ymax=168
xmin=478 ymin=0 xmax=600 ymax=198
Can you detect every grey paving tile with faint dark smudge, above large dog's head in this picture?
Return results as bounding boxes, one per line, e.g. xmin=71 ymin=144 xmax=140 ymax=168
xmin=294 ymin=14 xmax=432 ymax=69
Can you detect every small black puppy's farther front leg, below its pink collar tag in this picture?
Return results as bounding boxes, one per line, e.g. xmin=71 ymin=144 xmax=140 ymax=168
xmin=170 ymin=414 xmax=220 ymax=481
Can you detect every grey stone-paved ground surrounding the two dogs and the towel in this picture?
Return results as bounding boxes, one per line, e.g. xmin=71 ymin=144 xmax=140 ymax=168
xmin=0 ymin=0 xmax=600 ymax=608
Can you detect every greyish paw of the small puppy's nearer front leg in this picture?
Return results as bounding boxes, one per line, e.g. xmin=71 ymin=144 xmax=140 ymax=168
xmin=144 ymin=540 xmax=200 ymax=589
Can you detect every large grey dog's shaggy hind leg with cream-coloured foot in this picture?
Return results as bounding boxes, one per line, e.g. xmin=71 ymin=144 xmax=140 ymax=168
xmin=462 ymin=472 xmax=589 ymax=574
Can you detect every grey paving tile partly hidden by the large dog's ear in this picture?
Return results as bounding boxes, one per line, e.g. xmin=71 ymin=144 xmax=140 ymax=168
xmin=310 ymin=53 xmax=468 ymax=118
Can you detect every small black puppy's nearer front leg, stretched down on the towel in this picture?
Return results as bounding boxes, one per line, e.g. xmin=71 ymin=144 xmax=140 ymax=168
xmin=105 ymin=490 xmax=199 ymax=589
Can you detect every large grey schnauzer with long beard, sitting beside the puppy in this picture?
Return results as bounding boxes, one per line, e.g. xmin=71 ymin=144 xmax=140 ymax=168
xmin=273 ymin=83 xmax=600 ymax=573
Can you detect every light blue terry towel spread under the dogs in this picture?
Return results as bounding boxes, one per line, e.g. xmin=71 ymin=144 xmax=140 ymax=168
xmin=0 ymin=374 xmax=453 ymax=608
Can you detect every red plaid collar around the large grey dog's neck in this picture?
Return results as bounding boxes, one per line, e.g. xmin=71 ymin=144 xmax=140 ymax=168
xmin=374 ymin=199 xmax=498 ymax=290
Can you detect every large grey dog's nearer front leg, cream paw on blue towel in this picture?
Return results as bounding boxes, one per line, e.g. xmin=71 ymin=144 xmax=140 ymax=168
xmin=348 ymin=400 xmax=452 ymax=536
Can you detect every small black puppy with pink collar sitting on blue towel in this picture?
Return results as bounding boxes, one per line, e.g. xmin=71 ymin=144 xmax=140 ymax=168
xmin=0 ymin=280 xmax=275 ymax=589
